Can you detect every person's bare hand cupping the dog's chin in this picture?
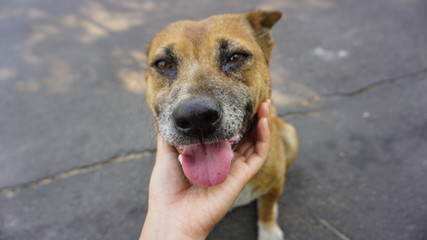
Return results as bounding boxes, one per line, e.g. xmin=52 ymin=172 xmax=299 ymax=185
xmin=140 ymin=100 xmax=271 ymax=240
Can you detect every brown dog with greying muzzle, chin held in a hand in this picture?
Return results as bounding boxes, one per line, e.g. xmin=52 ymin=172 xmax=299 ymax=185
xmin=146 ymin=11 xmax=298 ymax=239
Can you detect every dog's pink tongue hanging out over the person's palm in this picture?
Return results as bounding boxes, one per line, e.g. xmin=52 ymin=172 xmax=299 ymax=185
xmin=182 ymin=140 xmax=233 ymax=187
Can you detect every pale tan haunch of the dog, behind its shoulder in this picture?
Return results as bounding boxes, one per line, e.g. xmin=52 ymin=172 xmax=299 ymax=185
xmin=277 ymin=118 xmax=298 ymax=168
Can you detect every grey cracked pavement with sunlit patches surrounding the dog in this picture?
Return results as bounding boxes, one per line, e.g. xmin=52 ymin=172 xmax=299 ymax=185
xmin=0 ymin=0 xmax=427 ymax=240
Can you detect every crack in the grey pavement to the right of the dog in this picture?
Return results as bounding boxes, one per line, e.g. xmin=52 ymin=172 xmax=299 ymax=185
xmin=279 ymin=68 xmax=427 ymax=117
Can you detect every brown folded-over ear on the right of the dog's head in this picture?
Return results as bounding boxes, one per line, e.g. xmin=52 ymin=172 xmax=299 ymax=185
xmin=245 ymin=10 xmax=282 ymax=62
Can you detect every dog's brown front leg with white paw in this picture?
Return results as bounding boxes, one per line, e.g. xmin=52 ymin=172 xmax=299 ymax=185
xmin=258 ymin=179 xmax=285 ymax=240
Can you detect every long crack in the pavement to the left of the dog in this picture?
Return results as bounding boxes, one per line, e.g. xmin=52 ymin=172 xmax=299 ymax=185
xmin=0 ymin=150 xmax=156 ymax=198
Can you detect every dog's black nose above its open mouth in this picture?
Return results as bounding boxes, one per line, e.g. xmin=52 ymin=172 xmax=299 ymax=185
xmin=173 ymin=97 xmax=221 ymax=138
